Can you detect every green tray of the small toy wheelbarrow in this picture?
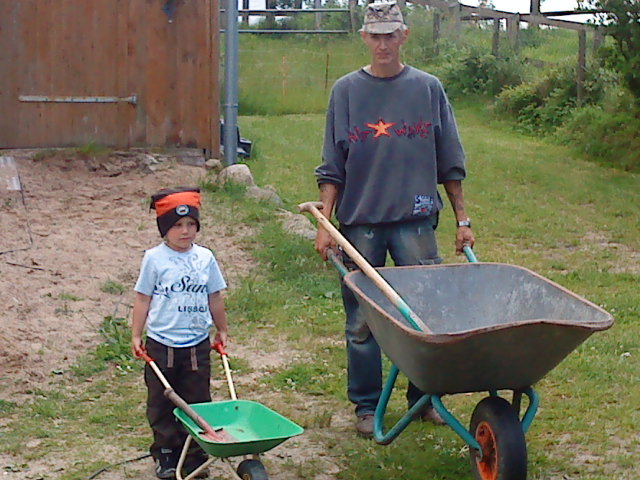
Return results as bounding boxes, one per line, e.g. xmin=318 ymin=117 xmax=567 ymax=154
xmin=173 ymin=400 xmax=303 ymax=458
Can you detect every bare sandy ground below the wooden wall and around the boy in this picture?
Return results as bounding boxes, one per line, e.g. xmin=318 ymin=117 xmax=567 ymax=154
xmin=0 ymin=151 xmax=344 ymax=480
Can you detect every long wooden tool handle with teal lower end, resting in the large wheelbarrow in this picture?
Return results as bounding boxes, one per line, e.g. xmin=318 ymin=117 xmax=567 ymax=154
xmin=298 ymin=202 xmax=433 ymax=334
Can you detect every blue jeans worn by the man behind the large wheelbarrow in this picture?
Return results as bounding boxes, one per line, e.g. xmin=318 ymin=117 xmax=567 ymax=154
xmin=340 ymin=214 xmax=442 ymax=416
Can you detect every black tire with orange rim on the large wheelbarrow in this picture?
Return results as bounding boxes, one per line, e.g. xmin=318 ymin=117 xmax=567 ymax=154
xmin=470 ymin=397 xmax=527 ymax=480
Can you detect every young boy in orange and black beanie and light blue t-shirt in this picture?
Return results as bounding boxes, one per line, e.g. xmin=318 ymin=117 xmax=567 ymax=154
xmin=132 ymin=187 xmax=227 ymax=479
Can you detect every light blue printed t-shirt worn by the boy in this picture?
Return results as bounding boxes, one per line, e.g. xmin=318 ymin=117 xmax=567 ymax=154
xmin=134 ymin=243 xmax=227 ymax=347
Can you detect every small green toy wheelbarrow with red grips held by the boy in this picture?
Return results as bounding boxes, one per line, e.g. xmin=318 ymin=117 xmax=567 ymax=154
xmin=143 ymin=344 xmax=304 ymax=480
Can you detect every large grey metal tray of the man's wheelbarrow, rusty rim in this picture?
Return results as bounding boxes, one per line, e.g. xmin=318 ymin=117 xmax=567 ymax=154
xmin=344 ymin=263 xmax=613 ymax=395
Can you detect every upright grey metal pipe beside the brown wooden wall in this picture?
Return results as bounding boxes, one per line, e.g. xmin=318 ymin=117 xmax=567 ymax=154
xmin=223 ymin=0 xmax=238 ymax=166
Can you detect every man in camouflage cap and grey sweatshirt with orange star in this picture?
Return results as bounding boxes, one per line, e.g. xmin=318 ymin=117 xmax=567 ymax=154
xmin=315 ymin=2 xmax=474 ymax=437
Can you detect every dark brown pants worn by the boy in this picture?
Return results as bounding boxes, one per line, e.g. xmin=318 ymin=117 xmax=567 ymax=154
xmin=144 ymin=338 xmax=211 ymax=458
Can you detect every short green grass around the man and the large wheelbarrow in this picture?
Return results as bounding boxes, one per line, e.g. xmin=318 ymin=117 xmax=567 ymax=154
xmin=241 ymin=104 xmax=640 ymax=480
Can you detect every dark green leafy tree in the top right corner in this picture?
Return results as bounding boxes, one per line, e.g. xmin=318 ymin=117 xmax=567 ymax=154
xmin=581 ymin=0 xmax=640 ymax=100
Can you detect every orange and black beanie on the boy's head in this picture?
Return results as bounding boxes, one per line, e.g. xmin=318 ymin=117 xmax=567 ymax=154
xmin=151 ymin=187 xmax=200 ymax=237
